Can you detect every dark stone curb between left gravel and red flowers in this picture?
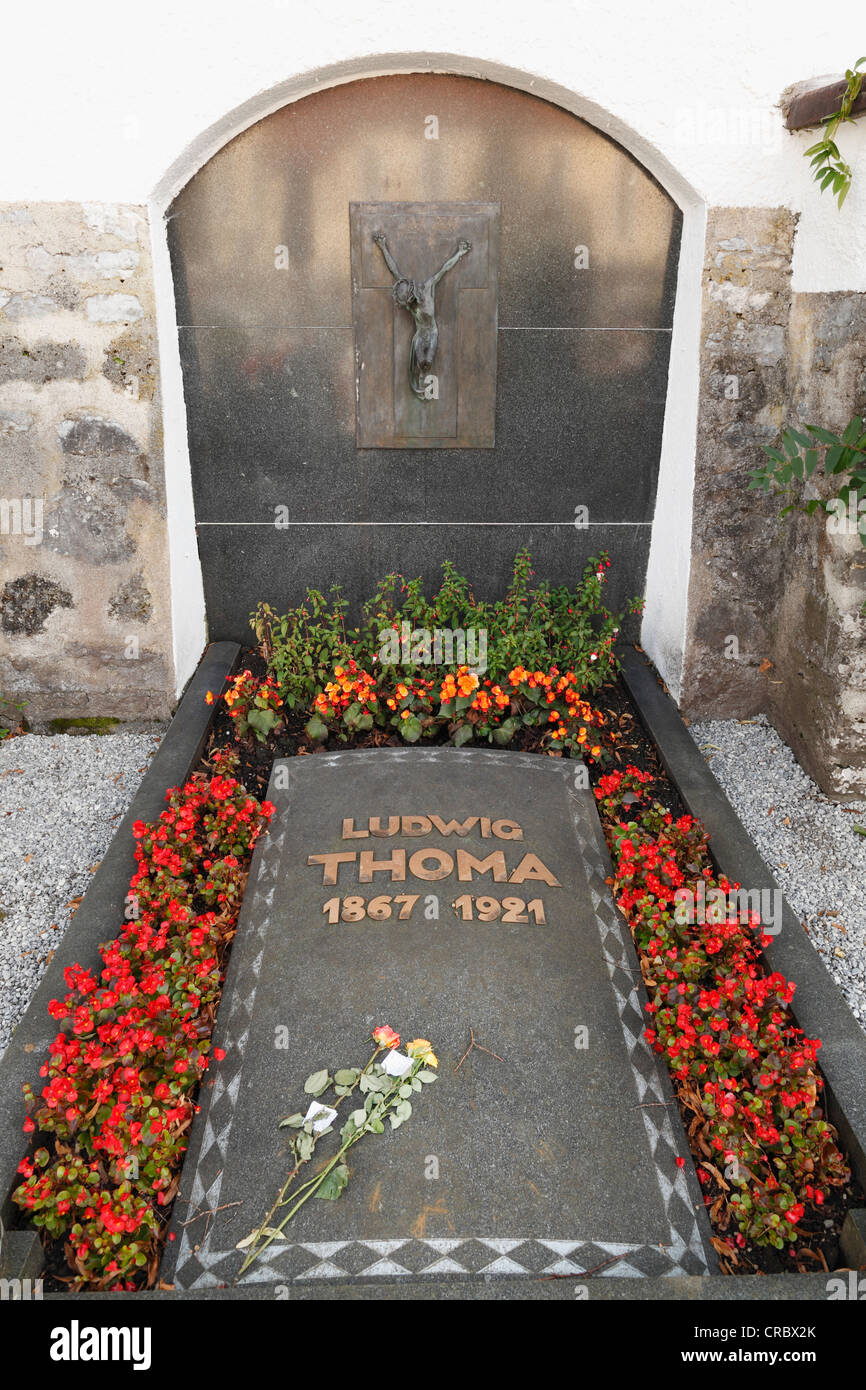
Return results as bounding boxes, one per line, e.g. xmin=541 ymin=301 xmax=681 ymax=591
xmin=0 ymin=642 xmax=240 ymax=1241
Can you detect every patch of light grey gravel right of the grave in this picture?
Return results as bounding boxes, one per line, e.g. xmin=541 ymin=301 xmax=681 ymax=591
xmin=691 ymin=716 xmax=866 ymax=1031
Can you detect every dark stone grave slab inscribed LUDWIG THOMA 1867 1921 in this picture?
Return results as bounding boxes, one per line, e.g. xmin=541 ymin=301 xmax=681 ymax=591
xmin=164 ymin=748 xmax=708 ymax=1289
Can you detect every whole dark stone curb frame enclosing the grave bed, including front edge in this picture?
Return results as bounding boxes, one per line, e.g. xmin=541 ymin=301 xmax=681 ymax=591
xmin=0 ymin=642 xmax=866 ymax=1307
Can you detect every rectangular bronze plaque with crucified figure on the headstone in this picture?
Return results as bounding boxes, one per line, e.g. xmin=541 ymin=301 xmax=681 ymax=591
xmin=349 ymin=203 xmax=499 ymax=449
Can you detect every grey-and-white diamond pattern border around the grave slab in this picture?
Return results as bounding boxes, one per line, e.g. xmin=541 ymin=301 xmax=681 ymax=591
xmin=168 ymin=748 xmax=709 ymax=1290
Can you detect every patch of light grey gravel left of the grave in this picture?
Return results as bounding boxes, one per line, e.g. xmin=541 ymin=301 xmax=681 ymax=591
xmin=0 ymin=734 xmax=160 ymax=1055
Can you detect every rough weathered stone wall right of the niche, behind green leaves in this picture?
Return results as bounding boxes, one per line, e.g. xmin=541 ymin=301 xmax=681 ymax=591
xmin=681 ymin=209 xmax=866 ymax=798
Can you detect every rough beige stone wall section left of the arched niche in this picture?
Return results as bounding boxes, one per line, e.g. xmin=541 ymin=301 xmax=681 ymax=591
xmin=0 ymin=203 xmax=174 ymax=723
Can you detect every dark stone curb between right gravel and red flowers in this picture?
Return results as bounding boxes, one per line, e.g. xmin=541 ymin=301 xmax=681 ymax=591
xmin=621 ymin=648 xmax=866 ymax=1195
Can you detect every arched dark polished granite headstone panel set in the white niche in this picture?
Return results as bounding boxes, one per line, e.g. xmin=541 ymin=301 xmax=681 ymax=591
xmin=168 ymin=74 xmax=681 ymax=641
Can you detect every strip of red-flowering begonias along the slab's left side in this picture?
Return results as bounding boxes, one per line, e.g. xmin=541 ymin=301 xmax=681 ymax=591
xmin=14 ymin=756 xmax=274 ymax=1287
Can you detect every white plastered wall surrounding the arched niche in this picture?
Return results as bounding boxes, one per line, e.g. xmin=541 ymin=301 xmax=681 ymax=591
xmin=0 ymin=0 xmax=866 ymax=694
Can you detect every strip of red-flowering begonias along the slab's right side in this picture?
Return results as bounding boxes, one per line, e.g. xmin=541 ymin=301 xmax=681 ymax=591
xmin=595 ymin=767 xmax=851 ymax=1248
